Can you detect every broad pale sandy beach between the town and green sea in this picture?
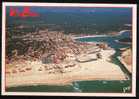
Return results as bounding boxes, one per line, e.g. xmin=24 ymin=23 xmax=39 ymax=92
xmin=6 ymin=50 xmax=126 ymax=87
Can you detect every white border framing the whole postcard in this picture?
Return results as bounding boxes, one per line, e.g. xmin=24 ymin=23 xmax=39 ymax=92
xmin=1 ymin=2 xmax=137 ymax=97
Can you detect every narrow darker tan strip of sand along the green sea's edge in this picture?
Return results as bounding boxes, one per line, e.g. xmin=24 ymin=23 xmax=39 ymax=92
xmin=6 ymin=76 xmax=126 ymax=88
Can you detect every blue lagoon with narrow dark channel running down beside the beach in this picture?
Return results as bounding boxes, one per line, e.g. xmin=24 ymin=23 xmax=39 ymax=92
xmin=76 ymin=31 xmax=132 ymax=79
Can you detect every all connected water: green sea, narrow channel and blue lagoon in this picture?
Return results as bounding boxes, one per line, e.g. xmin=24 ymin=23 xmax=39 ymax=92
xmin=7 ymin=32 xmax=132 ymax=93
